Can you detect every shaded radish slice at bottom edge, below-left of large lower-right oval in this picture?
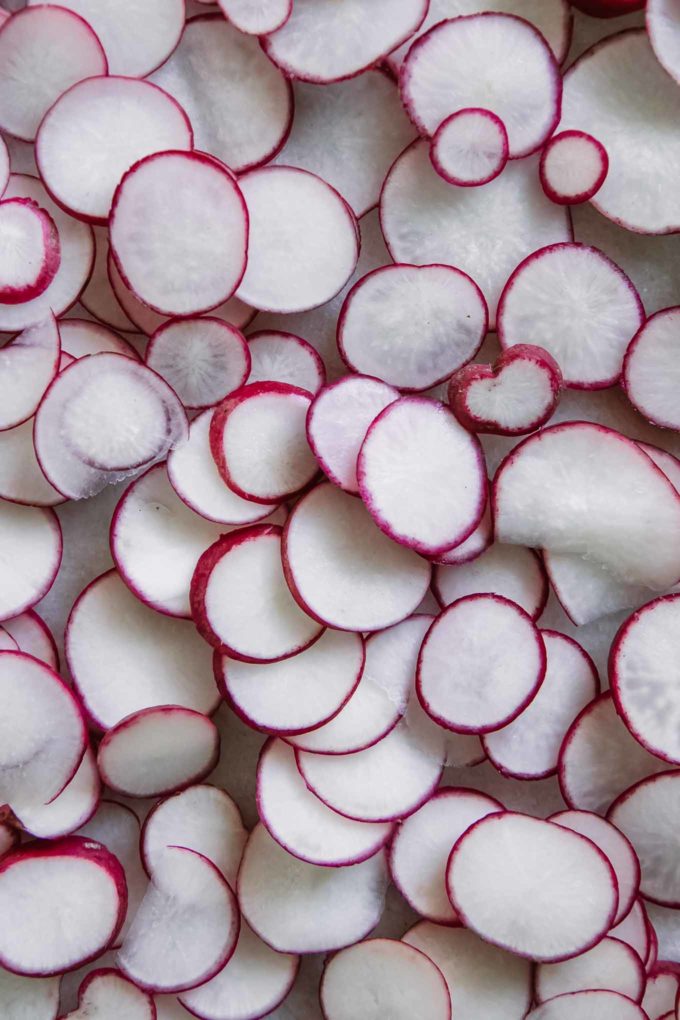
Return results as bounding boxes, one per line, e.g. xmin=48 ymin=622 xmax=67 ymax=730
xmin=403 ymin=921 xmax=532 ymax=1020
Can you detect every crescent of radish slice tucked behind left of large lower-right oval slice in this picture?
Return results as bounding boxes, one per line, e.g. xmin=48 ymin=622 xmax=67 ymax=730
xmin=389 ymin=786 xmax=504 ymax=925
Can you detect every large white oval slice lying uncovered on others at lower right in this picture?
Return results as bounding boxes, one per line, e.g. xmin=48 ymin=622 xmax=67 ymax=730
xmin=447 ymin=811 xmax=618 ymax=963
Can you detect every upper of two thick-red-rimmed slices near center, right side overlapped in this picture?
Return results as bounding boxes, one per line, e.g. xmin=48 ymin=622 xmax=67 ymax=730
xmin=210 ymin=383 xmax=318 ymax=504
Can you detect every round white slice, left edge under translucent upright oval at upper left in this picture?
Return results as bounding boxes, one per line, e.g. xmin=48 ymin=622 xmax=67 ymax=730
xmin=238 ymin=168 xmax=360 ymax=312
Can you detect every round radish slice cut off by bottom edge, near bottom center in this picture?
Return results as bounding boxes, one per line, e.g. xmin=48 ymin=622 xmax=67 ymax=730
xmin=319 ymin=938 xmax=452 ymax=1020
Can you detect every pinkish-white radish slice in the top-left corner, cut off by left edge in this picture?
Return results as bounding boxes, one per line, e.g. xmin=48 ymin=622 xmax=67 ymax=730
xmin=0 ymin=3 xmax=108 ymax=142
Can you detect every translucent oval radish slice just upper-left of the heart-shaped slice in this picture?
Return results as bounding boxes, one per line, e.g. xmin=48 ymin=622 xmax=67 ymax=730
xmin=337 ymin=265 xmax=488 ymax=390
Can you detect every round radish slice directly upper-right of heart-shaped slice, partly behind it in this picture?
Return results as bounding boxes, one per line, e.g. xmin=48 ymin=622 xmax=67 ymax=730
xmin=498 ymin=244 xmax=644 ymax=390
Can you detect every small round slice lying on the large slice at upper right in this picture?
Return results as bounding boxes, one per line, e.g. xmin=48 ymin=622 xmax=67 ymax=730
xmin=430 ymin=108 xmax=509 ymax=188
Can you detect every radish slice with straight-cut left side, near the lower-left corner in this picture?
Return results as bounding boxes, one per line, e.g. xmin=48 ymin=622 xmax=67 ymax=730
xmin=117 ymin=847 xmax=240 ymax=992
